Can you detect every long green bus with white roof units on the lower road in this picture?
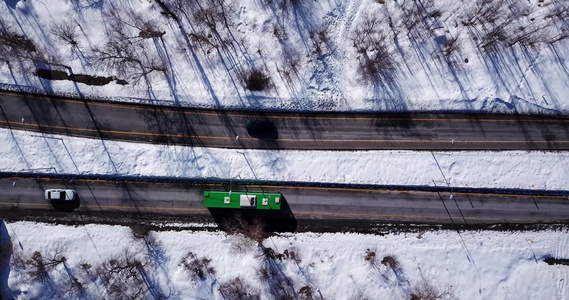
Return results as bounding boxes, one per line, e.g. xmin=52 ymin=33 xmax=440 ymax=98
xmin=204 ymin=191 xmax=282 ymax=210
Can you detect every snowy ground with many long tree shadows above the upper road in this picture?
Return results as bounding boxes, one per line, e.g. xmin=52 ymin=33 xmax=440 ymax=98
xmin=0 ymin=0 xmax=569 ymax=114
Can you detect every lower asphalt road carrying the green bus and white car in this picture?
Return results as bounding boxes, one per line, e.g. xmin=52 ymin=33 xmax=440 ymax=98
xmin=0 ymin=178 xmax=569 ymax=226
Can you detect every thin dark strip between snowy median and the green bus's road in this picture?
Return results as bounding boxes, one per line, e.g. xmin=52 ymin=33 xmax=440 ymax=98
xmin=0 ymin=172 xmax=569 ymax=199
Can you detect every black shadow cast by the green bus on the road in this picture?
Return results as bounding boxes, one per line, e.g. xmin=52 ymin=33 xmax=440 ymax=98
xmin=208 ymin=195 xmax=297 ymax=232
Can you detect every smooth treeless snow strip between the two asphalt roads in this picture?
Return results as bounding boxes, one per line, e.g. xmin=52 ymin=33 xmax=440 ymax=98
xmin=0 ymin=129 xmax=569 ymax=190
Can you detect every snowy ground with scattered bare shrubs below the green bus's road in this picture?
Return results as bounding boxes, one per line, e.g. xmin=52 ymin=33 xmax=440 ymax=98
xmin=2 ymin=222 xmax=569 ymax=300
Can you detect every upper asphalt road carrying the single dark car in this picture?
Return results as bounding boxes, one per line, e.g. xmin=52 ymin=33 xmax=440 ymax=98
xmin=0 ymin=93 xmax=569 ymax=150
